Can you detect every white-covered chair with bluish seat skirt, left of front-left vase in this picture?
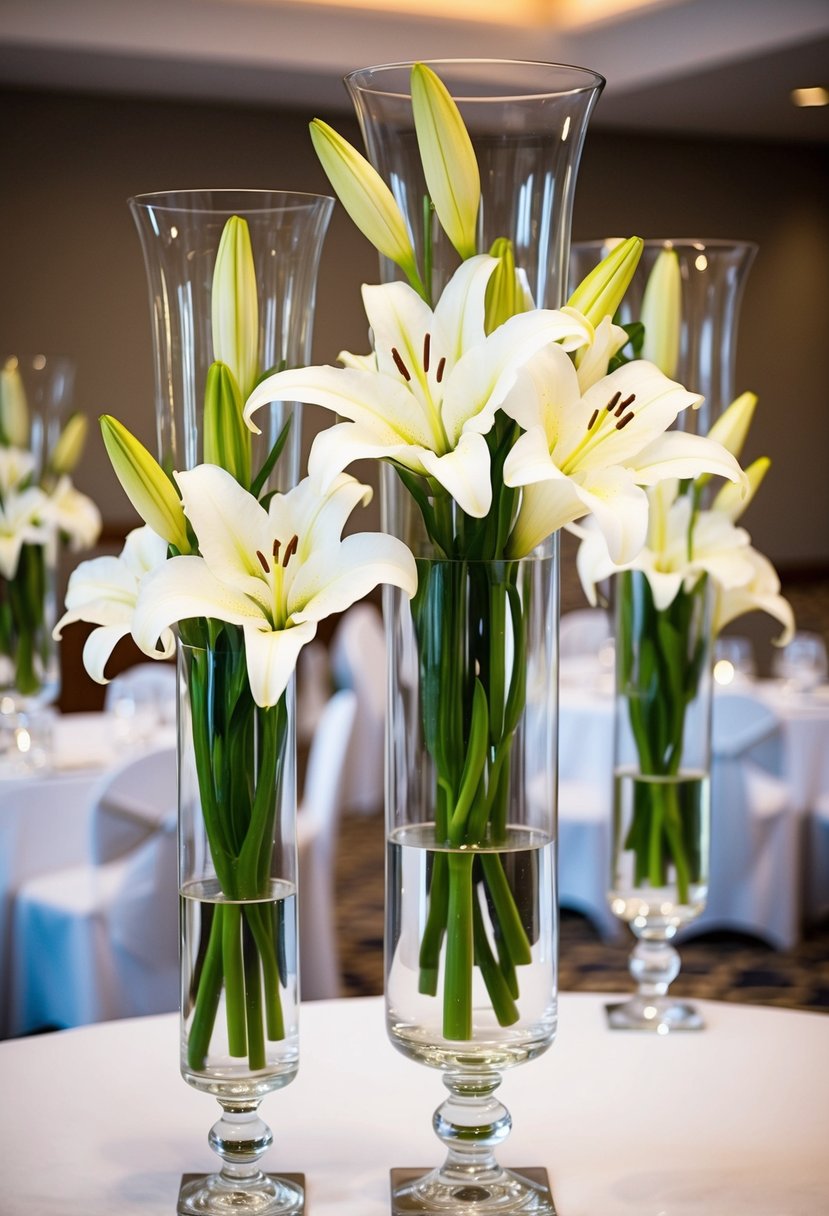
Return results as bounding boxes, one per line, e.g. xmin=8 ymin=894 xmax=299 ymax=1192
xmin=10 ymin=748 xmax=179 ymax=1034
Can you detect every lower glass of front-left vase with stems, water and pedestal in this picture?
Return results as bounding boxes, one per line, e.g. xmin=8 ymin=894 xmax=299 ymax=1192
xmin=177 ymin=642 xmax=303 ymax=1216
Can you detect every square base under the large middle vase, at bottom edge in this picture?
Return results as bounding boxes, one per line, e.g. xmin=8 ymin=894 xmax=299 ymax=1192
xmin=390 ymin=1166 xmax=556 ymax=1216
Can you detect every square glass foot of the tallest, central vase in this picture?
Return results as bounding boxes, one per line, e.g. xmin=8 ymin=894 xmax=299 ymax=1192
xmin=391 ymin=1166 xmax=556 ymax=1216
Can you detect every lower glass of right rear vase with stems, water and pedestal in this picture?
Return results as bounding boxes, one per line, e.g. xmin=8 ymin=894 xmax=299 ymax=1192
xmin=608 ymin=570 xmax=712 ymax=1035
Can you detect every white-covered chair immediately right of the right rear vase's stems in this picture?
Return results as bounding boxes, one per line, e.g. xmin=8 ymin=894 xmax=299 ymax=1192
xmin=688 ymin=693 xmax=800 ymax=950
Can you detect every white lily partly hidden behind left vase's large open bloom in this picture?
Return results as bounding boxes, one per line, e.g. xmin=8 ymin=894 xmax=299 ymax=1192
xmin=53 ymin=525 xmax=175 ymax=683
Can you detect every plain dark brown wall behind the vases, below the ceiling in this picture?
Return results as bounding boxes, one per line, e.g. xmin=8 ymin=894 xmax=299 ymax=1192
xmin=0 ymin=85 xmax=829 ymax=567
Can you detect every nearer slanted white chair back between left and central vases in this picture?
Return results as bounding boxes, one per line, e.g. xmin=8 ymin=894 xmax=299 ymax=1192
xmin=297 ymin=688 xmax=357 ymax=1001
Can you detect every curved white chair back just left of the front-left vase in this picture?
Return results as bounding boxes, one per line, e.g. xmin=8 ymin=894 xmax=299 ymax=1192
xmin=90 ymin=748 xmax=176 ymax=866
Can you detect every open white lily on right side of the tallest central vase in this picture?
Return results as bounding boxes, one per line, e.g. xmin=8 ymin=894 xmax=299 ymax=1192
xmin=502 ymin=345 xmax=743 ymax=563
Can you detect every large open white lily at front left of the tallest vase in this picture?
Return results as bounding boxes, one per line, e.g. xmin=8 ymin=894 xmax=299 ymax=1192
xmin=244 ymin=254 xmax=593 ymax=518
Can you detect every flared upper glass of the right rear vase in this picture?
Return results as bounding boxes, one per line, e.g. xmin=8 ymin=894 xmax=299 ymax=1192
xmin=570 ymin=237 xmax=757 ymax=435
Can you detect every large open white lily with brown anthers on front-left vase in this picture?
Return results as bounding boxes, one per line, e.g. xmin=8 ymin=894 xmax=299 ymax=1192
xmin=134 ymin=465 xmax=417 ymax=706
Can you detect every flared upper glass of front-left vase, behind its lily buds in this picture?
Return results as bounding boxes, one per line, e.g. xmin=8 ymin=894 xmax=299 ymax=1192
xmin=129 ymin=190 xmax=333 ymax=490
